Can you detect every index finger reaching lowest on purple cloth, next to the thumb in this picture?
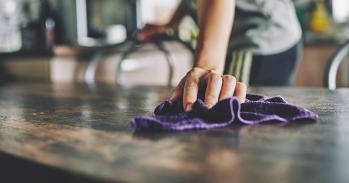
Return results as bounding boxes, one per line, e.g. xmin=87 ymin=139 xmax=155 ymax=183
xmin=183 ymin=68 xmax=205 ymax=111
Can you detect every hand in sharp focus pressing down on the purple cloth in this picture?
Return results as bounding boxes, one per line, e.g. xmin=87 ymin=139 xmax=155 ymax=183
xmin=171 ymin=67 xmax=247 ymax=111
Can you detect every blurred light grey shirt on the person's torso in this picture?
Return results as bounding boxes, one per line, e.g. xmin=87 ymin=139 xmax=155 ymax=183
xmin=230 ymin=0 xmax=302 ymax=55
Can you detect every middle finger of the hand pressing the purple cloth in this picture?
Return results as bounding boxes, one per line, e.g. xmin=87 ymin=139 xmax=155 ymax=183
xmin=204 ymin=71 xmax=223 ymax=108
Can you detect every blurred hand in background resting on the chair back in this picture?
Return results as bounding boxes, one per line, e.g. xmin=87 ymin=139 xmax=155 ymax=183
xmin=137 ymin=24 xmax=174 ymax=42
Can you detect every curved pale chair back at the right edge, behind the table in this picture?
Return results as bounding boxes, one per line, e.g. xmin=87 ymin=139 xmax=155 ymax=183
xmin=324 ymin=40 xmax=349 ymax=90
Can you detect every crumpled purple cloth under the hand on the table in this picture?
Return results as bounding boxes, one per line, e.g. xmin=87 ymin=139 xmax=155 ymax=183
xmin=131 ymin=94 xmax=318 ymax=131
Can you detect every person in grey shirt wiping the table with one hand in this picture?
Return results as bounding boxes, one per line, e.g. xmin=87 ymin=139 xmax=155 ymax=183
xmin=138 ymin=0 xmax=301 ymax=111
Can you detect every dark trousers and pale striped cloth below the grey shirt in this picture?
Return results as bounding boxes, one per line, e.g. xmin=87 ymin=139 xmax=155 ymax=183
xmin=224 ymin=43 xmax=302 ymax=86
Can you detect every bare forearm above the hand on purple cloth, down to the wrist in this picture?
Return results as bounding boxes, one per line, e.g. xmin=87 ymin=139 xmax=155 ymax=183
xmin=194 ymin=0 xmax=235 ymax=73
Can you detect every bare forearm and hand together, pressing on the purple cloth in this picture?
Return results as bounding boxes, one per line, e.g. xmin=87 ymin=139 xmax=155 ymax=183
xmin=171 ymin=0 xmax=247 ymax=111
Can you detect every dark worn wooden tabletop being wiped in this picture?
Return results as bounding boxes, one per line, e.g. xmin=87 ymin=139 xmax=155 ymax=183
xmin=0 ymin=83 xmax=349 ymax=182
